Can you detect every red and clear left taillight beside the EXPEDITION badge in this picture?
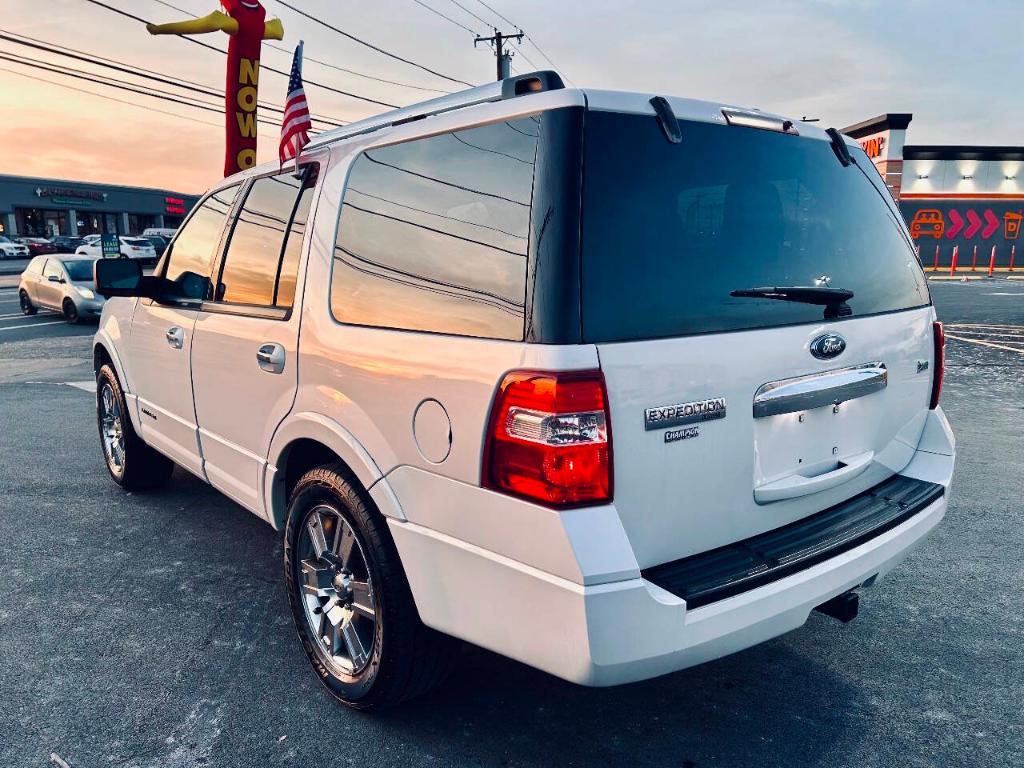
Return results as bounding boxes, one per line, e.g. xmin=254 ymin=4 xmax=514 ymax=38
xmin=482 ymin=371 xmax=612 ymax=507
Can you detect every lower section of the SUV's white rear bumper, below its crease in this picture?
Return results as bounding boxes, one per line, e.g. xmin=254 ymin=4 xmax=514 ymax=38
xmin=389 ymin=487 xmax=946 ymax=686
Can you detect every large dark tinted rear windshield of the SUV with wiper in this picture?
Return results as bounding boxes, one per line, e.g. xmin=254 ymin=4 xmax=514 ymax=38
xmin=582 ymin=112 xmax=930 ymax=341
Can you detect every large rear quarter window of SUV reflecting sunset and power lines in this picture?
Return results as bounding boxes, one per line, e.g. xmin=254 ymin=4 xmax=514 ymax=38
xmin=331 ymin=118 xmax=539 ymax=339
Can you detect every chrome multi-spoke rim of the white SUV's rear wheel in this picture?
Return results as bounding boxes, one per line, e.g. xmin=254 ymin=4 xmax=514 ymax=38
xmin=296 ymin=505 xmax=377 ymax=676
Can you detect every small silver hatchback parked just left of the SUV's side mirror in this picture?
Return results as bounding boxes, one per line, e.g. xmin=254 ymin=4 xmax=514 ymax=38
xmin=17 ymin=255 xmax=103 ymax=324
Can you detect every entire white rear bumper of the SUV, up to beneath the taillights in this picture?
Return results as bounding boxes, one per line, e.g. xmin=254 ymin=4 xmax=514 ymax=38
xmin=387 ymin=411 xmax=953 ymax=686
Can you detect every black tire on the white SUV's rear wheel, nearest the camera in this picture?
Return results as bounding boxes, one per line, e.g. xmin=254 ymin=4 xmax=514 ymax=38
xmin=285 ymin=465 xmax=461 ymax=710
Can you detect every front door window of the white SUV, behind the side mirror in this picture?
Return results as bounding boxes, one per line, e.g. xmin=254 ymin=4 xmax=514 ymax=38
xmin=164 ymin=184 xmax=240 ymax=299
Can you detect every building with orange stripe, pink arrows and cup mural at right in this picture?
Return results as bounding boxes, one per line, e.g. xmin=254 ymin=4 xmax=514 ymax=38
xmin=843 ymin=113 xmax=1024 ymax=271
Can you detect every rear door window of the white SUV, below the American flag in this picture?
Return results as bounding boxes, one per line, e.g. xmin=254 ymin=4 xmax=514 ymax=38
xmin=217 ymin=167 xmax=308 ymax=307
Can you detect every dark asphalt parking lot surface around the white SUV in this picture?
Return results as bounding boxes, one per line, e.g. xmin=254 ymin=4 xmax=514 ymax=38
xmin=0 ymin=281 xmax=1024 ymax=768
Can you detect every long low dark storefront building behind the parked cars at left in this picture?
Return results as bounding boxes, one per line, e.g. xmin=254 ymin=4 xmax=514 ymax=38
xmin=0 ymin=176 xmax=199 ymax=238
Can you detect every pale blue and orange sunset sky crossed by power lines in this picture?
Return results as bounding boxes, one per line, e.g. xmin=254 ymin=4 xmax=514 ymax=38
xmin=0 ymin=0 xmax=1024 ymax=193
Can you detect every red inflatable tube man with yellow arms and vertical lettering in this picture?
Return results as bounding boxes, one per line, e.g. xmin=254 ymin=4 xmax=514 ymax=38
xmin=145 ymin=0 xmax=285 ymax=176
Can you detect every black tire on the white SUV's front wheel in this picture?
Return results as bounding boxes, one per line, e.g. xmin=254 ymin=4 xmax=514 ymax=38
xmin=96 ymin=364 xmax=174 ymax=490
